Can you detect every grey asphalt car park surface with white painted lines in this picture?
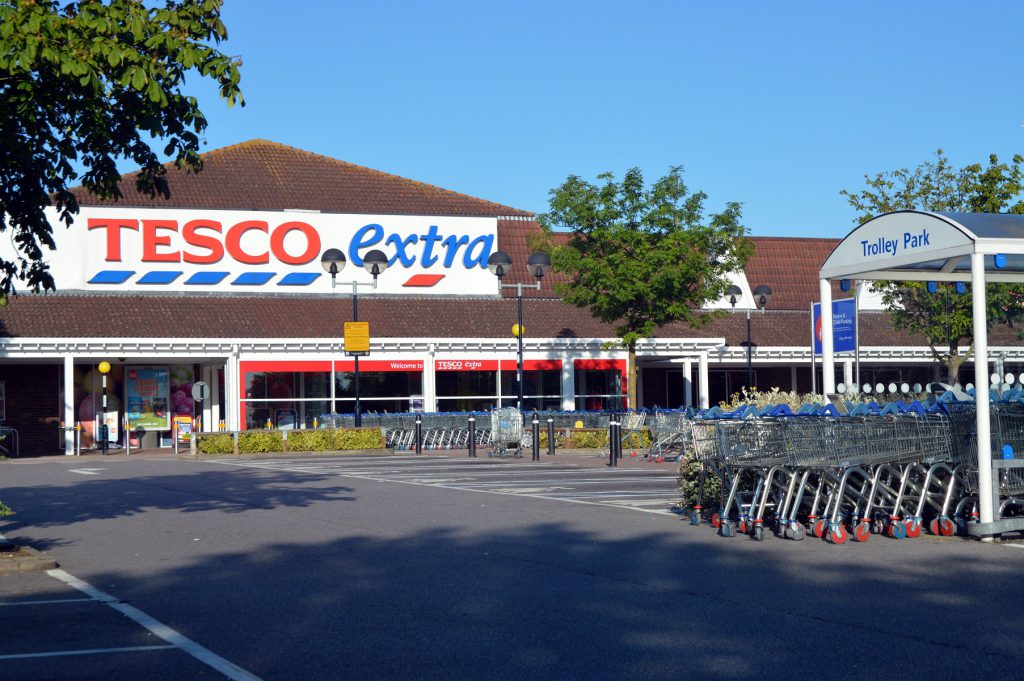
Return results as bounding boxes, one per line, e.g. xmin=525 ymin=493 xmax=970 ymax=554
xmin=0 ymin=456 xmax=1024 ymax=679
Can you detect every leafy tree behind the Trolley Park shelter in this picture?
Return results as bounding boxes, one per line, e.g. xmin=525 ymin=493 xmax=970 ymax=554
xmin=840 ymin=150 xmax=1024 ymax=380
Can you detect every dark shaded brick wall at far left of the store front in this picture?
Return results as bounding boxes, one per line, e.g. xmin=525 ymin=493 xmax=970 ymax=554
xmin=0 ymin=365 xmax=63 ymax=457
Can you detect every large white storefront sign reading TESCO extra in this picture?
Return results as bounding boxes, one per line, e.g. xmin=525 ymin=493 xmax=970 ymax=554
xmin=12 ymin=207 xmax=499 ymax=295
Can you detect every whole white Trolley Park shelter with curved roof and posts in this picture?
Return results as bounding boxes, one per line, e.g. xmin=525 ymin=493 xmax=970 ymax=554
xmin=819 ymin=211 xmax=1024 ymax=537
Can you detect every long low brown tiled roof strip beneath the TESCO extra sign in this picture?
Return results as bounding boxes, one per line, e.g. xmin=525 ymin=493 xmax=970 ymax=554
xmin=0 ymin=294 xmax=1020 ymax=347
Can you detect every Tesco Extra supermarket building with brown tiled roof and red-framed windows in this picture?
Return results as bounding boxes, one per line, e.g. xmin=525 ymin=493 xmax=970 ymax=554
xmin=0 ymin=140 xmax=1024 ymax=455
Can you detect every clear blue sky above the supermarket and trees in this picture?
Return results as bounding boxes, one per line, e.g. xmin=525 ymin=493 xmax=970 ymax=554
xmin=180 ymin=0 xmax=1024 ymax=237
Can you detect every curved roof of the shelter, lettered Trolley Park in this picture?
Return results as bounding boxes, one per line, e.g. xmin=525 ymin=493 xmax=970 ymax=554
xmin=821 ymin=210 xmax=1024 ymax=282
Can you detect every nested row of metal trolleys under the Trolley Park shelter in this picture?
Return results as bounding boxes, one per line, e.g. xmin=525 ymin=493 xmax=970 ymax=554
xmin=682 ymin=403 xmax=1024 ymax=544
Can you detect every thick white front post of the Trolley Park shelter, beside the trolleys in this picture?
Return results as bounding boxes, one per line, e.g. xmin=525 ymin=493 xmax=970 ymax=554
xmin=971 ymin=253 xmax=995 ymax=524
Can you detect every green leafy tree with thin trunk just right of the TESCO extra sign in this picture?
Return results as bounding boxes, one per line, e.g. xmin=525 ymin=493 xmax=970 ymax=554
xmin=538 ymin=167 xmax=753 ymax=409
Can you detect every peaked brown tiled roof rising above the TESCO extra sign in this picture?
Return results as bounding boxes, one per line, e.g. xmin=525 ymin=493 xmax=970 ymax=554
xmin=74 ymin=139 xmax=531 ymax=217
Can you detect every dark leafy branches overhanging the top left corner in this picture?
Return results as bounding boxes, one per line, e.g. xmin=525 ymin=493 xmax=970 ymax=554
xmin=0 ymin=0 xmax=244 ymax=292
